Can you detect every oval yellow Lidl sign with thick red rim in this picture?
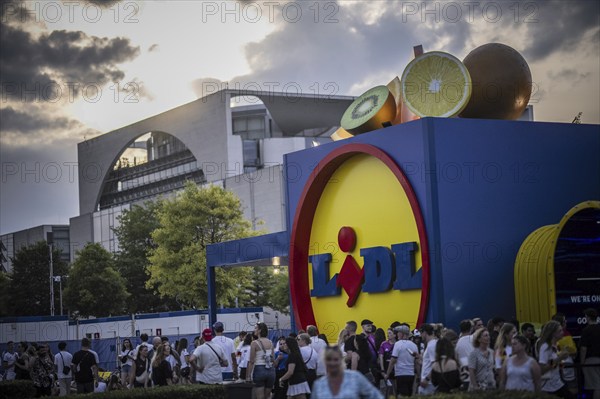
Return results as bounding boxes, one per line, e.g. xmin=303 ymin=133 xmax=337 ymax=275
xmin=290 ymin=144 xmax=429 ymax=340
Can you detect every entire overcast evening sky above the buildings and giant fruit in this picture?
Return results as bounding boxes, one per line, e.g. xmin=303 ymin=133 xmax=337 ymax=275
xmin=0 ymin=0 xmax=600 ymax=234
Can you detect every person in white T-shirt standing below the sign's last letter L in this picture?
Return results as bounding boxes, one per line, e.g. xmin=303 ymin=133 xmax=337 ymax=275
xmin=386 ymin=325 xmax=419 ymax=396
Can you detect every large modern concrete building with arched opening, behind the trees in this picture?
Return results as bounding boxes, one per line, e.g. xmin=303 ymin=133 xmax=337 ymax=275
xmin=70 ymin=89 xmax=354 ymax=259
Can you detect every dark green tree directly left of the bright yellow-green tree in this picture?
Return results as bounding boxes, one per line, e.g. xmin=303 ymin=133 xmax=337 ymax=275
xmin=114 ymin=201 xmax=177 ymax=313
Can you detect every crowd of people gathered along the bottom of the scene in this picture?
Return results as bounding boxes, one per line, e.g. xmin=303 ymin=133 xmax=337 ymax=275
xmin=2 ymin=309 xmax=600 ymax=399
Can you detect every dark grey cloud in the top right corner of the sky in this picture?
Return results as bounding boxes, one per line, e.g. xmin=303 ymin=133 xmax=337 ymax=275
xmin=524 ymin=0 xmax=600 ymax=61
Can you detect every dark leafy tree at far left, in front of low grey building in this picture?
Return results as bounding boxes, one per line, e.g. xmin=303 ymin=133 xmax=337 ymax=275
xmin=8 ymin=241 xmax=69 ymax=316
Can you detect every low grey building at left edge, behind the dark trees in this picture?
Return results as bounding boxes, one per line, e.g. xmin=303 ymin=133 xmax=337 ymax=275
xmin=0 ymin=224 xmax=71 ymax=273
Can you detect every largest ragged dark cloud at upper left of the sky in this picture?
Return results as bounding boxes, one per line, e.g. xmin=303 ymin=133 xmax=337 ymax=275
xmin=0 ymin=25 xmax=140 ymax=102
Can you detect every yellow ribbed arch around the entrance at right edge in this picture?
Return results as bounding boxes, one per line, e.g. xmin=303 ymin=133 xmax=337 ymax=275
xmin=514 ymin=201 xmax=600 ymax=323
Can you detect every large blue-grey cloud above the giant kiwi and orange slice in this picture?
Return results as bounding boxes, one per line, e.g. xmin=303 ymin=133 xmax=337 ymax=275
xmin=229 ymin=1 xmax=470 ymax=95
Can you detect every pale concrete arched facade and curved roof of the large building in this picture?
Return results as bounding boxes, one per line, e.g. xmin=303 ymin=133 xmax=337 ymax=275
xmin=77 ymin=89 xmax=354 ymax=215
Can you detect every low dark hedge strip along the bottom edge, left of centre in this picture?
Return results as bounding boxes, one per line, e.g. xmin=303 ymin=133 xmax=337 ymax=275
xmin=88 ymin=385 xmax=227 ymax=399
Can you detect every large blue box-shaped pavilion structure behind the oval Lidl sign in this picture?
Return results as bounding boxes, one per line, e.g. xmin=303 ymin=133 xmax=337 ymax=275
xmin=207 ymin=118 xmax=600 ymax=328
